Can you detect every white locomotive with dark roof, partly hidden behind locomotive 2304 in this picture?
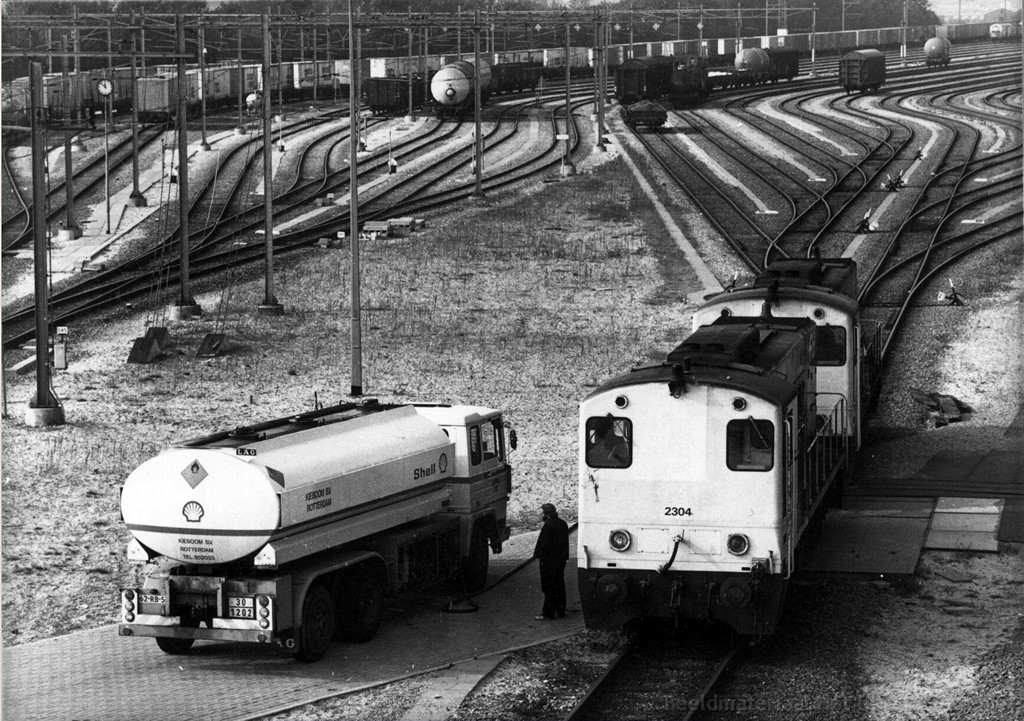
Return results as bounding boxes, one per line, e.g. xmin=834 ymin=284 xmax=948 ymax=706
xmin=693 ymin=258 xmax=879 ymax=448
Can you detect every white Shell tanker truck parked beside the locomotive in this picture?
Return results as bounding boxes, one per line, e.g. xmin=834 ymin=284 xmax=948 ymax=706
xmin=119 ymin=400 xmax=516 ymax=662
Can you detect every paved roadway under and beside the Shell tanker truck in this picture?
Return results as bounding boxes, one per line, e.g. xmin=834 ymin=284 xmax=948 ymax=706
xmin=0 ymin=534 xmax=584 ymax=721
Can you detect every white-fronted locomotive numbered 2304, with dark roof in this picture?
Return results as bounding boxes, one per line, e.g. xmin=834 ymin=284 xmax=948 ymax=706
xmin=578 ymin=316 xmax=849 ymax=635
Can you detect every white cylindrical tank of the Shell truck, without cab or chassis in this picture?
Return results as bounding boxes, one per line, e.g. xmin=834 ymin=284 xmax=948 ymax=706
xmin=121 ymin=407 xmax=454 ymax=564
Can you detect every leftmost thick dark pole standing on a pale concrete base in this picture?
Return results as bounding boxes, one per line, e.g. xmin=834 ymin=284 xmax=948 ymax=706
xmin=25 ymin=61 xmax=65 ymax=427
